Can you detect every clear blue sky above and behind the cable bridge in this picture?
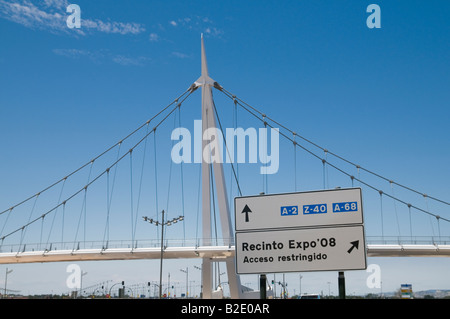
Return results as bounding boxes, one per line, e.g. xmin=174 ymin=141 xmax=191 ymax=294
xmin=0 ymin=0 xmax=450 ymax=298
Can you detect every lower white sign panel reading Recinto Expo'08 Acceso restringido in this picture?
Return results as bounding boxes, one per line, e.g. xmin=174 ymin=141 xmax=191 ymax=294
xmin=236 ymin=225 xmax=367 ymax=274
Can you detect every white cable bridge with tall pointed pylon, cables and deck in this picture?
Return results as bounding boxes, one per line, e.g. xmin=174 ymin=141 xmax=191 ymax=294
xmin=0 ymin=39 xmax=450 ymax=297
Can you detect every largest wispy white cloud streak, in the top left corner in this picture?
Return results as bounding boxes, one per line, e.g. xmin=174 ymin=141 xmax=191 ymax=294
xmin=0 ymin=0 xmax=145 ymax=35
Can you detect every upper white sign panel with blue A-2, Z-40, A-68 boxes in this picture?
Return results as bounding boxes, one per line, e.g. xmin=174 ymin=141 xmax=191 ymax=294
xmin=234 ymin=188 xmax=363 ymax=231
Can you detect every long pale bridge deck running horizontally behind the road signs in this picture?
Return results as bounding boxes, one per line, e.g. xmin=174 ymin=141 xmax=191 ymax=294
xmin=0 ymin=244 xmax=450 ymax=264
